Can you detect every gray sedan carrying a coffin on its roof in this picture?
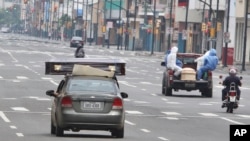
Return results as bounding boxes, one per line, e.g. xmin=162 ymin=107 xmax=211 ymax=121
xmin=46 ymin=75 xmax=128 ymax=138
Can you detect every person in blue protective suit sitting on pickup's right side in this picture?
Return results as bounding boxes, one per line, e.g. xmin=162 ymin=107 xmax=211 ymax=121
xmin=197 ymin=48 xmax=218 ymax=80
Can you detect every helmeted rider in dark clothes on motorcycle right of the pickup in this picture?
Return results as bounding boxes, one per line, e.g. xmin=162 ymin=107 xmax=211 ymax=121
xmin=222 ymin=68 xmax=242 ymax=108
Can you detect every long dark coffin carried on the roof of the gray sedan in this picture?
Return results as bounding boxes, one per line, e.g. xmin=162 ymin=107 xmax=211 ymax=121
xmin=45 ymin=58 xmax=126 ymax=77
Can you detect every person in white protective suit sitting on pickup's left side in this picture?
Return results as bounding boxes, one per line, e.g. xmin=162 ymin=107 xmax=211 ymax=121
xmin=167 ymin=46 xmax=182 ymax=77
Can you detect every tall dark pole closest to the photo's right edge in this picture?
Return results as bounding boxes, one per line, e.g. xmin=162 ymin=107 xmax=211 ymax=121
xmin=241 ymin=0 xmax=249 ymax=71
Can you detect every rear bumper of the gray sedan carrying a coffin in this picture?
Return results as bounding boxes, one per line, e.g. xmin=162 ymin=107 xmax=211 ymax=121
xmin=57 ymin=111 xmax=125 ymax=130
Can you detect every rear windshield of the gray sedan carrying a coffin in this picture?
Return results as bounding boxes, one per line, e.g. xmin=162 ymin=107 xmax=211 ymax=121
xmin=67 ymin=79 xmax=116 ymax=93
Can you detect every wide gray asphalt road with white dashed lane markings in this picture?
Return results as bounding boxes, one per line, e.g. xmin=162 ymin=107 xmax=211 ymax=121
xmin=0 ymin=33 xmax=250 ymax=141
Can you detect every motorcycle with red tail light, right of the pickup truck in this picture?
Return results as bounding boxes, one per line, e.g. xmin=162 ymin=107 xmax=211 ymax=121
xmin=220 ymin=76 xmax=242 ymax=113
